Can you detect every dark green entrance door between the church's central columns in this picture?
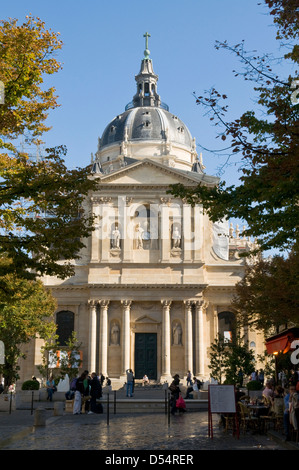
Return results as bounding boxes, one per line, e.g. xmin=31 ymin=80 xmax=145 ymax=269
xmin=135 ymin=333 xmax=157 ymax=380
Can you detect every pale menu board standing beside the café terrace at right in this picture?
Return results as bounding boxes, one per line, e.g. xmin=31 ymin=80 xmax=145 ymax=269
xmin=209 ymin=385 xmax=236 ymax=413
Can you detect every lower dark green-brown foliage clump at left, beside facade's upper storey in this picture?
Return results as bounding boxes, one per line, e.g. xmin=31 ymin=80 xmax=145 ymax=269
xmin=0 ymin=147 xmax=95 ymax=278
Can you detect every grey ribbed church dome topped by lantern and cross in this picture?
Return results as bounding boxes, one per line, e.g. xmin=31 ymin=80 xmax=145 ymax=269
xmin=93 ymin=33 xmax=202 ymax=173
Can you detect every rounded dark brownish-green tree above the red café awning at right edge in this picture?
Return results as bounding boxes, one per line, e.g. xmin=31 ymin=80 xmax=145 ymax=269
xmin=232 ymin=252 xmax=299 ymax=333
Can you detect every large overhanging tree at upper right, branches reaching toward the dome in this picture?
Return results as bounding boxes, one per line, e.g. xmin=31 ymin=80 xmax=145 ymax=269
xmin=170 ymin=0 xmax=299 ymax=255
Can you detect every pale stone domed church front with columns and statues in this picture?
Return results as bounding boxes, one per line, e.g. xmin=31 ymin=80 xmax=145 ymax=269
xmin=21 ymin=44 xmax=262 ymax=384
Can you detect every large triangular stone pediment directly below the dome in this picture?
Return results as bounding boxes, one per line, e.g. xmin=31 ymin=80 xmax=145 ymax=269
xmin=96 ymin=159 xmax=215 ymax=186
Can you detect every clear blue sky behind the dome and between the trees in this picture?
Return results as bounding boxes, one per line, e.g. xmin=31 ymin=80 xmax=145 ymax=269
xmin=1 ymin=0 xmax=277 ymax=183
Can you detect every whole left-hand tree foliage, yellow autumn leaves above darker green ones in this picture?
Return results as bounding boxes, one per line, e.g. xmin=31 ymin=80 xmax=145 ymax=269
xmin=0 ymin=16 xmax=96 ymax=278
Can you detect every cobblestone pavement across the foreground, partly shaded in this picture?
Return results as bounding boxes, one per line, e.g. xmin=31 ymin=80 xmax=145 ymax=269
xmin=0 ymin=410 xmax=286 ymax=452
